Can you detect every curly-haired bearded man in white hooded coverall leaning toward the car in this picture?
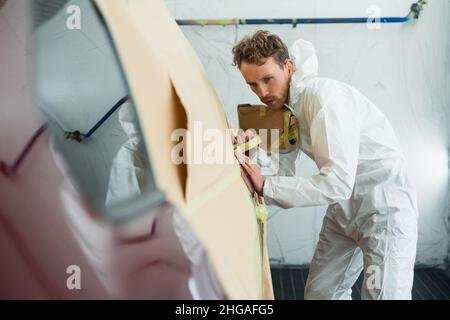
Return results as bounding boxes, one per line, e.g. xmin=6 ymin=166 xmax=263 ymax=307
xmin=233 ymin=31 xmax=418 ymax=299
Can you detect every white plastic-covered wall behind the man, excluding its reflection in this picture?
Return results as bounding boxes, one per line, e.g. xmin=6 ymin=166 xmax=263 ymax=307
xmin=166 ymin=0 xmax=450 ymax=265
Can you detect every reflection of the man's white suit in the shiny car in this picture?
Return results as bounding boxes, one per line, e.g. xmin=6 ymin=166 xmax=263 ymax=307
xmin=106 ymin=103 xmax=225 ymax=300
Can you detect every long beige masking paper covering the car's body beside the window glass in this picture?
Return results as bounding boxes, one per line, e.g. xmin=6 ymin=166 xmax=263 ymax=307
xmin=96 ymin=0 xmax=272 ymax=299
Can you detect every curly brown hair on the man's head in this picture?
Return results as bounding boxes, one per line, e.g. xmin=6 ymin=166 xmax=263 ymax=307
xmin=232 ymin=30 xmax=289 ymax=68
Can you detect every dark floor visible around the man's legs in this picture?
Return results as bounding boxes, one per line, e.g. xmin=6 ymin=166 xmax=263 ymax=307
xmin=271 ymin=267 xmax=450 ymax=300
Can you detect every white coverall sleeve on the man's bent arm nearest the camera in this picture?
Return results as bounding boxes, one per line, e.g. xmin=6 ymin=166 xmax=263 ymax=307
xmin=263 ymin=94 xmax=360 ymax=208
